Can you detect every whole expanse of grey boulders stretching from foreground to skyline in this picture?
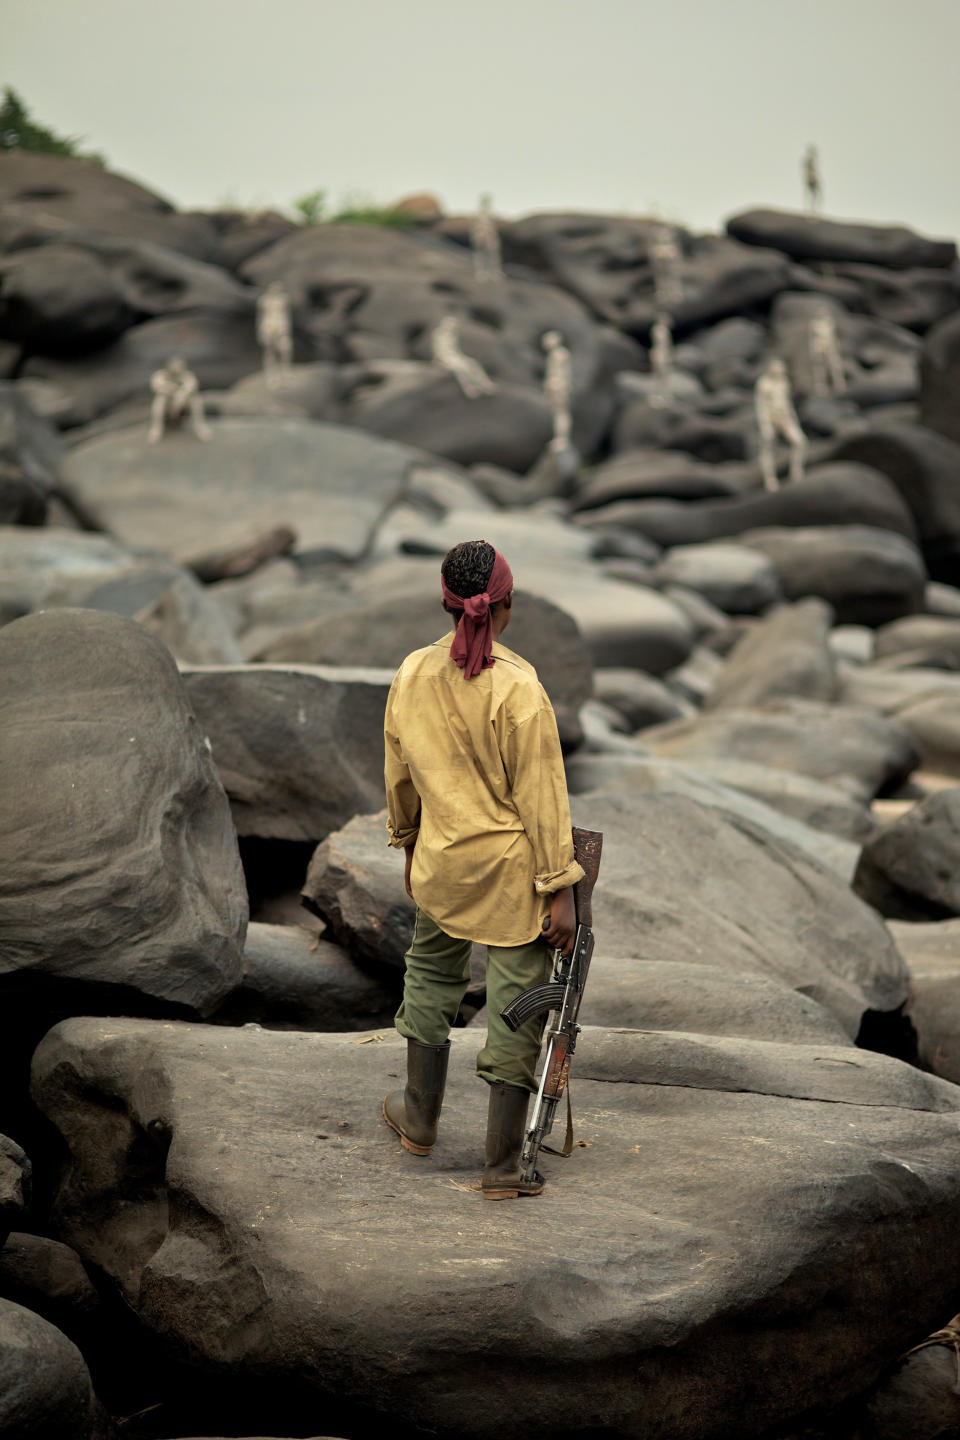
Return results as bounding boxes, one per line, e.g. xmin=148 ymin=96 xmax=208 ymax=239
xmin=0 ymin=154 xmax=960 ymax=1440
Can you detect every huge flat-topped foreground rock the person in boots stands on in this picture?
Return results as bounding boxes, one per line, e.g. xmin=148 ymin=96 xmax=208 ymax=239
xmin=35 ymin=1020 xmax=960 ymax=1440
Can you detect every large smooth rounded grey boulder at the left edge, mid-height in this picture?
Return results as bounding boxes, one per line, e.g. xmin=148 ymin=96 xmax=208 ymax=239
xmin=0 ymin=609 xmax=248 ymax=1015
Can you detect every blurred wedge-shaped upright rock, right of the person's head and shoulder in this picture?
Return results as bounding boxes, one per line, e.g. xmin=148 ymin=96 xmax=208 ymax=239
xmin=704 ymin=599 xmax=838 ymax=710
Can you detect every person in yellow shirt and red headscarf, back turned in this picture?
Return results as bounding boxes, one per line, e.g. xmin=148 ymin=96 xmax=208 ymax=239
xmin=383 ymin=540 xmax=583 ymax=1200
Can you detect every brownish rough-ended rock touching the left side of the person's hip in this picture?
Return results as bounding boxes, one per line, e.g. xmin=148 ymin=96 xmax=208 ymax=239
xmin=302 ymin=809 xmax=415 ymax=968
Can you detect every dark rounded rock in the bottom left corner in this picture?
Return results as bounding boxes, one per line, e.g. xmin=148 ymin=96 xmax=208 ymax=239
xmin=0 ymin=1300 xmax=94 ymax=1440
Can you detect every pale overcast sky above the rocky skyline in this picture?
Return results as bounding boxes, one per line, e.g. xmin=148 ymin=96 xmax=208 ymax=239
xmin=7 ymin=0 xmax=960 ymax=236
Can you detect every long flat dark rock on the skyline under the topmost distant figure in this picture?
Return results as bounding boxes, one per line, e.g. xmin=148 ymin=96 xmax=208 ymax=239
xmin=727 ymin=210 xmax=957 ymax=269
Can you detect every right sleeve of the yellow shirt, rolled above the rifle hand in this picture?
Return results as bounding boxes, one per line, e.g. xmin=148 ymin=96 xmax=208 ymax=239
xmin=502 ymin=688 xmax=583 ymax=894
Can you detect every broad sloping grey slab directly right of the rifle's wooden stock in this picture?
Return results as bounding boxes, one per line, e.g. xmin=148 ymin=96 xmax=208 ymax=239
xmin=571 ymin=795 xmax=907 ymax=1038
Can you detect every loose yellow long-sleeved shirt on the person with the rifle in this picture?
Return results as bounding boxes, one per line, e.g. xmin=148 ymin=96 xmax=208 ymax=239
xmin=384 ymin=634 xmax=583 ymax=945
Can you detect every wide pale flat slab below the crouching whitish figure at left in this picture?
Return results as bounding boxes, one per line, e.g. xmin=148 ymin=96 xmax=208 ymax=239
xmin=56 ymin=416 xmax=440 ymax=560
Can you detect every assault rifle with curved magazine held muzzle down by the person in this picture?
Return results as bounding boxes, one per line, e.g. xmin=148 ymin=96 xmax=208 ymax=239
xmin=499 ymin=828 xmax=603 ymax=1182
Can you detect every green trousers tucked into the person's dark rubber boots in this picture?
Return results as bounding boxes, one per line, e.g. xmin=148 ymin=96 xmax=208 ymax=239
xmin=396 ymin=909 xmax=553 ymax=1090
